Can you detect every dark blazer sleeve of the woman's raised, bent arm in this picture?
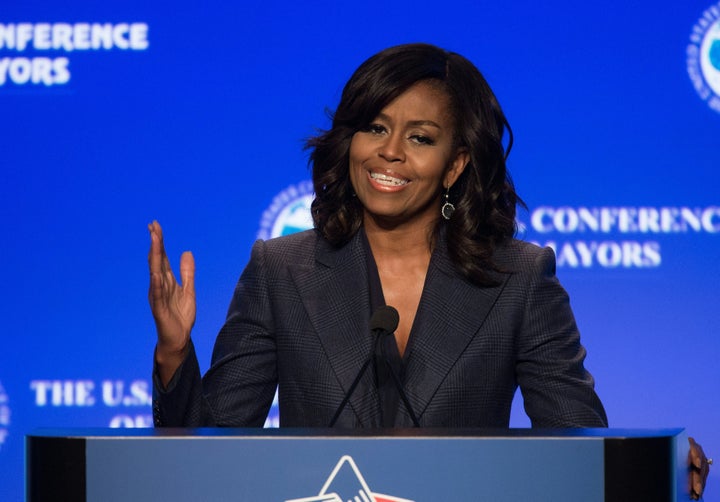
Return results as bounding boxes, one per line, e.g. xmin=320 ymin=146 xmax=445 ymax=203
xmin=153 ymin=241 xmax=277 ymax=427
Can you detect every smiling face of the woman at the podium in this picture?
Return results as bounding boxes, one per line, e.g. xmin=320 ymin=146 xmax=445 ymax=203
xmin=350 ymin=82 xmax=469 ymax=226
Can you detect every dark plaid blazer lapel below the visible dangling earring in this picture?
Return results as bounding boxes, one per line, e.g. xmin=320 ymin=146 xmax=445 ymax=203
xmin=396 ymin=240 xmax=509 ymax=424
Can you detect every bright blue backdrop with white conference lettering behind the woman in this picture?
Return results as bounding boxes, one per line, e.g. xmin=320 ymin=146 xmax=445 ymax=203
xmin=0 ymin=0 xmax=720 ymax=500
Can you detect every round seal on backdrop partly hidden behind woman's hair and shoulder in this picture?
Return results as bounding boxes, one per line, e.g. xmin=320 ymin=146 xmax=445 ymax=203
xmin=257 ymin=180 xmax=314 ymax=240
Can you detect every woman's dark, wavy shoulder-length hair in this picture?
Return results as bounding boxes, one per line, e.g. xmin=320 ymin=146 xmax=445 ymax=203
xmin=306 ymin=44 xmax=524 ymax=285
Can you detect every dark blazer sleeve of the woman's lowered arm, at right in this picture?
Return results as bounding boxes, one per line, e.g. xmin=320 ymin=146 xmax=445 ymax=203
xmin=516 ymin=248 xmax=607 ymax=428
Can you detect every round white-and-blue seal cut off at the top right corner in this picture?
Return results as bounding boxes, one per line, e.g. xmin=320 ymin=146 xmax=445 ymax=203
xmin=686 ymin=2 xmax=720 ymax=113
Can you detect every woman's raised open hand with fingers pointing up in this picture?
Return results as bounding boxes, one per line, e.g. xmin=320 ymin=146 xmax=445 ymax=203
xmin=148 ymin=221 xmax=196 ymax=386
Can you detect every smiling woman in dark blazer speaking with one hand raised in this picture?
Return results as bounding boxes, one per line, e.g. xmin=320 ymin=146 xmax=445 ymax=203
xmin=149 ymin=44 xmax=708 ymax=494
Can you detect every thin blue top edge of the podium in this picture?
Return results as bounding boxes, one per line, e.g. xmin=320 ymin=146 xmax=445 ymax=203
xmin=26 ymin=427 xmax=684 ymax=439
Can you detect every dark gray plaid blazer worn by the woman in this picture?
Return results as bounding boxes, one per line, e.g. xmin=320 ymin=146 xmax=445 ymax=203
xmin=153 ymin=230 xmax=607 ymax=428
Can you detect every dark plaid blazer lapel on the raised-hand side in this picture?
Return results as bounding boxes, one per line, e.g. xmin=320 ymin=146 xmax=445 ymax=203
xmin=291 ymin=232 xmax=380 ymax=427
